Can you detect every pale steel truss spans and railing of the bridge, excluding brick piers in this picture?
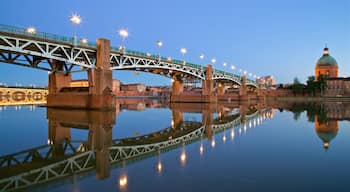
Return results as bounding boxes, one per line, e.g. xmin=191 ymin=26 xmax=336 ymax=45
xmin=0 ymin=25 xmax=259 ymax=88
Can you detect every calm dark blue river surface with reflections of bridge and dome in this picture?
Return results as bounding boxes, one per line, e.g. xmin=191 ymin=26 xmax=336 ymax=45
xmin=0 ymin=100 xmax=350 ymax=192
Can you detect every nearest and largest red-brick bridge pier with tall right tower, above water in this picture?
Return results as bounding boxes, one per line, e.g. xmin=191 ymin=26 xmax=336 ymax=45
xmin=47 ymin=39 xmax=115 ymax=110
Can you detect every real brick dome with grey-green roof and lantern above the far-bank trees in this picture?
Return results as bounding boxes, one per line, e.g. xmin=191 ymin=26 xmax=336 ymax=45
xmin=315 ymin=47 xmax=338 ymax=80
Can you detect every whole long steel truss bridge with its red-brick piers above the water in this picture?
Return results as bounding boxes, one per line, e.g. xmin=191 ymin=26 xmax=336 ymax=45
xmin=0 ymin=25 xmax=263 ymax=109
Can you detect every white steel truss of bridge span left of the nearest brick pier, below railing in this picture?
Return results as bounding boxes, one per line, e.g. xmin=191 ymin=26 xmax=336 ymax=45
xmin=0 ymin=35 xmax=96 ymax=72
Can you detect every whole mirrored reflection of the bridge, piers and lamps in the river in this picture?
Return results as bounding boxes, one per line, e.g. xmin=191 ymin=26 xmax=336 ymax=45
xmin=0 ymin=100 xmax=272 ymax=191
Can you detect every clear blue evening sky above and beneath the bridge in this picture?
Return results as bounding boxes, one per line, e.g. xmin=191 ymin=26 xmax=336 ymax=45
xmin=0 ymin=0 xmax=350 ymax=85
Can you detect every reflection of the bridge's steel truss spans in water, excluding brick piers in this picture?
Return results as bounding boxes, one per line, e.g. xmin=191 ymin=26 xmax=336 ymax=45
xmin=0 ymin=111 xmax=266 ymax=191
